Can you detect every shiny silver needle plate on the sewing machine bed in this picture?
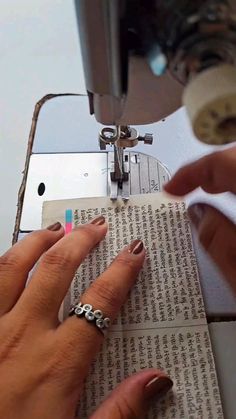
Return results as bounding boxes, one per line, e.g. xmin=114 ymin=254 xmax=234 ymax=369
xmin=20 ymin=151 xmax=170 ymax=233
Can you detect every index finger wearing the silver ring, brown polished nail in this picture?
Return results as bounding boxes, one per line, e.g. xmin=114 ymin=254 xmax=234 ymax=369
xmin=58 ymin=240 xmax=145 ymax=379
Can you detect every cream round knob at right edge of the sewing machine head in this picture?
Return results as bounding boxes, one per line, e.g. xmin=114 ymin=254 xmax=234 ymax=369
xmin=183 ymin=65 xmax=236 ymax=144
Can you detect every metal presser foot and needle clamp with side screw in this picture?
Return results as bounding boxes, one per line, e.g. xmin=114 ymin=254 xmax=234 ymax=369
xmin=99 ymin=126 xmax=153 ymax=200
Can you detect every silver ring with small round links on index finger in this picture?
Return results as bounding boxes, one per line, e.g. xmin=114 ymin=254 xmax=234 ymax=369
xmin=69 ymin=303 xmax=111 ymax=334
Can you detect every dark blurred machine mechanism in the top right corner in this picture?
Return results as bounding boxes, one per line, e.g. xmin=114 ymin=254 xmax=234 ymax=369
xmin=151 ymin=0 xmax=236 ymax=84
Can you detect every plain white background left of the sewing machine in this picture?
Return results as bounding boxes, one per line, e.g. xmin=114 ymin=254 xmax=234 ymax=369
xmin=0 ymin=0 xmax=85 ymax=254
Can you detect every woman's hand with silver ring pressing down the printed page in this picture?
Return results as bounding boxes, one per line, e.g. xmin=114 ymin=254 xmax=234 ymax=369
xmin=0 ymin=217 xmax=172 ymax=419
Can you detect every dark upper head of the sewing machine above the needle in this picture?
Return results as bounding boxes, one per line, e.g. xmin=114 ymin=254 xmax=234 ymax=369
xmin=75 ymin=0 xmax=236 ymax=144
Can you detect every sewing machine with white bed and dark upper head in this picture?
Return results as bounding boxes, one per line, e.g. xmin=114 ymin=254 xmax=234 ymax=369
xmin=14 ymin=0 xmax=236 ymax=418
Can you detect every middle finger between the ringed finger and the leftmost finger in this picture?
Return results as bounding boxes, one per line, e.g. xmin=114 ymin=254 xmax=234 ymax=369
xmin=16 ymin=217 xmax=107 ymax=324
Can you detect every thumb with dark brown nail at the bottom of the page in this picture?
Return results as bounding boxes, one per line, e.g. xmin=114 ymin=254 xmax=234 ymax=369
xmin=90 ymin=369 xmax=173 ymax=419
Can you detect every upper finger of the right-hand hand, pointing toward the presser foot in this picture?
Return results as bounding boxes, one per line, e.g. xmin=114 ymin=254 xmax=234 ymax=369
xmin=165 ymin=147 xmax=236 ymax=196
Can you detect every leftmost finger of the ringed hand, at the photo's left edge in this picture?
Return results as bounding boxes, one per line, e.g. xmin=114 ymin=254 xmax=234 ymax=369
xmin=0 ymin=223 xmax=64 ymax=315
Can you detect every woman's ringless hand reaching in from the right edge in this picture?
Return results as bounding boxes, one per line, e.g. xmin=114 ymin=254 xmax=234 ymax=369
xmin=165 ymin=147 xmax=236 ymax=292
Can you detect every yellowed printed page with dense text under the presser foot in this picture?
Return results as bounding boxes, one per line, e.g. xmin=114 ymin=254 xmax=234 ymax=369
xmin=43 ymin=193 xmax=223 ymax=419
